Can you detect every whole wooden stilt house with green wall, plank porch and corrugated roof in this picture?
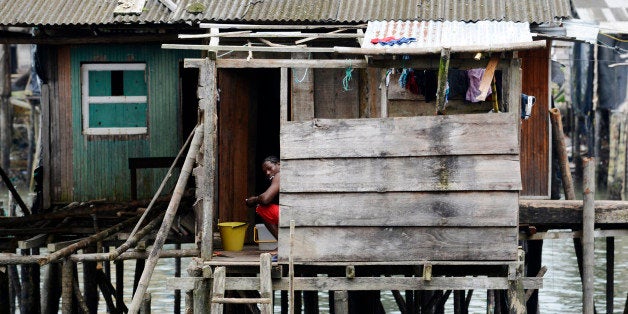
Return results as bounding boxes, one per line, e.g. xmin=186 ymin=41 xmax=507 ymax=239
xmin=0 ymin=0 xmax=592 ymax=313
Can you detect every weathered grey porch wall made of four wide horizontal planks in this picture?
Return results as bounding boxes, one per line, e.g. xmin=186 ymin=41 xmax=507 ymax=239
xmin=279 ymin=113 xmax=521 ymax=262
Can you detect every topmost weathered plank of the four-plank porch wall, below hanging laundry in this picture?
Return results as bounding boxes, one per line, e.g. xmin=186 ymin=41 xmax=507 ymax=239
xmin=281 ymin=114 xmax=519 ymax=158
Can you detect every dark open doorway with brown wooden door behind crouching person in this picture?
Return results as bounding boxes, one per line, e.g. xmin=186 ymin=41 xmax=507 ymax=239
xmin=218 ymin=69 xmax=280 ymax=223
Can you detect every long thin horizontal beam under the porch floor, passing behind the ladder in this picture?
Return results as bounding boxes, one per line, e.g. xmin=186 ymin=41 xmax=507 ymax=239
xmin=168 ymin=277 xmax=543 ymax=291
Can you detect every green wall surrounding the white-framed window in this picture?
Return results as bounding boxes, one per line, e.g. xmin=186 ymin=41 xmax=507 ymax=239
xmin=62 ymin=45 xmax=199 ymax=201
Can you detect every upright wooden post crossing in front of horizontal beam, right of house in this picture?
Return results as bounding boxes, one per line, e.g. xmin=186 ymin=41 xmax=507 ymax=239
xmin=582 ymin=158 xmax=595 ymax=314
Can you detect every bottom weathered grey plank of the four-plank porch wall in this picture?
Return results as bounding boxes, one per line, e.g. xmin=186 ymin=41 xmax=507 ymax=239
xmin=279 ymin=227 xmax=517 ymax=262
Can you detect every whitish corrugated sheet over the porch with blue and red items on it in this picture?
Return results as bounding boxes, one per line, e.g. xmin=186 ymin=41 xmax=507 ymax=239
xmin=362 ymin=21 xmax=532 ymax=49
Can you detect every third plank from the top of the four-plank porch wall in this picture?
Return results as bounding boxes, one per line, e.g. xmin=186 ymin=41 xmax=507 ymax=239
xmin=279 ymin=191 xmax=519 ymax=227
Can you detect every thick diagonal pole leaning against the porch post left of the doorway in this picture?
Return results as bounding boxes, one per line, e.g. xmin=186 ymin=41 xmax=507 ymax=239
xmin=129 ymin=124 xmax=203 ymax=314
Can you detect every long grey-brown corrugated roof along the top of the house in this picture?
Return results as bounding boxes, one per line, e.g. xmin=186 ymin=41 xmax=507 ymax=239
xmin=0 ymin=0 xmax=570 ymax=26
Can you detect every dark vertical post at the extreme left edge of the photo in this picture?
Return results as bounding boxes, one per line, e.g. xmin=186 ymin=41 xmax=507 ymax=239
xmin=0 ymin=44 xmax=13 ymax=170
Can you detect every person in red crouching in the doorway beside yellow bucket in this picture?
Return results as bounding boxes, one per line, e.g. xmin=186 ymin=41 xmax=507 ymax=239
xmin=244 ymin=156 xmax=280 ymax=238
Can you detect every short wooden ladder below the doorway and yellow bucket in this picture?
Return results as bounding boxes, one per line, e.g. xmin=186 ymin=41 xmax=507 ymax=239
xmin=211 ymin=253 xmax=273 ymax=314
